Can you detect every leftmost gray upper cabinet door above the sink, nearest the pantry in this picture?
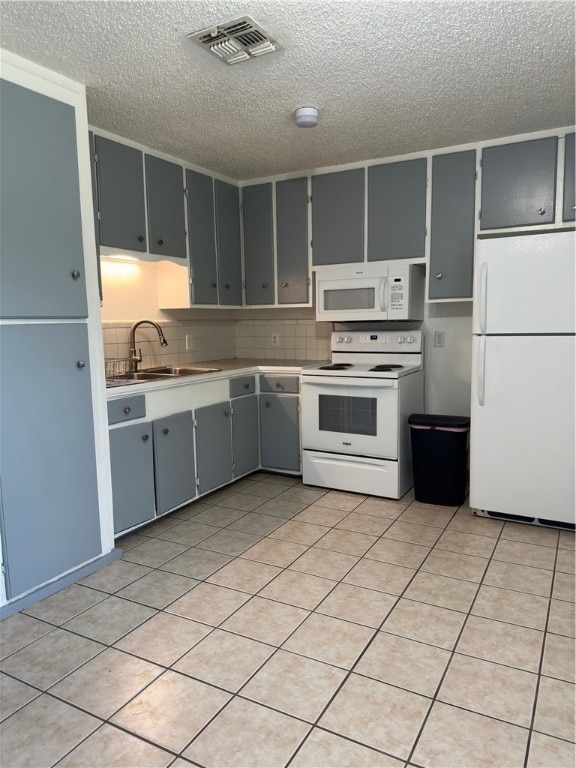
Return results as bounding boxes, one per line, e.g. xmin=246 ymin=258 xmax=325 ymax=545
xmin=94 ymin=136 xmax=147 ymax=251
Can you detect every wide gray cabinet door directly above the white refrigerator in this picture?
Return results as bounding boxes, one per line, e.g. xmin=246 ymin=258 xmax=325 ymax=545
xmin=480 ymin=136 xmax=558 ymax=229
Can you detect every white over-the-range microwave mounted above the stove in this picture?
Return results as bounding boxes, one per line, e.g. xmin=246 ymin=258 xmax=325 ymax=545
xmin=315 ymin=262 xmax=424 ymax=322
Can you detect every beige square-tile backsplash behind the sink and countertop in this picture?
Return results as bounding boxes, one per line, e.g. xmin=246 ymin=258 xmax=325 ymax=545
xmin=102 ymin=320 xmax=332 ymax=368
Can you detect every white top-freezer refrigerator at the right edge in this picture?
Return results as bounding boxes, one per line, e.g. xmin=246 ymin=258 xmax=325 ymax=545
xmin=470 ymin=232 xmax=575 ymax=525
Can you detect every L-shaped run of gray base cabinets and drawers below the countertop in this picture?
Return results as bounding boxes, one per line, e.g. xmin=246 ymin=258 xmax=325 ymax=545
xmin=108 ymin=366 xmax=301 ymax=535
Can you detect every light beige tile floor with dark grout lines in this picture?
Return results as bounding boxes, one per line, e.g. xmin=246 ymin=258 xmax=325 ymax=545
xmin=0 ymin=473 xmax=575 ymax=768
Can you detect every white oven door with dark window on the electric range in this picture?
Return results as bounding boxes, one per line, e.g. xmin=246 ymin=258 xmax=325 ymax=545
xmin=301 ymin=376 xmax=398 ymax=459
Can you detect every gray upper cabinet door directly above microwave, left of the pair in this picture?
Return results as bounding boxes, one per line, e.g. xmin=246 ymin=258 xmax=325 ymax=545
xmin=312 ymin=168 xmax=364 ymax=266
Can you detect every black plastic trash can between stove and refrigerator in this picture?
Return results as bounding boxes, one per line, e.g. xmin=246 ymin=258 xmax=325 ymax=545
xmin=408 ymin=413 xmax=470 ymax=507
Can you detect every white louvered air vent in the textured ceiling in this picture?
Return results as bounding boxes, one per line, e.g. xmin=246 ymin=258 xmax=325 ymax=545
xmin=186 ymin=16 xmax=282 ymax=64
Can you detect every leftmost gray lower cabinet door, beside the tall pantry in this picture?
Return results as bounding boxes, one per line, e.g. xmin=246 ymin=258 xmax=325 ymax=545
xmin=109 ymin=422 xmax=155 ymax=533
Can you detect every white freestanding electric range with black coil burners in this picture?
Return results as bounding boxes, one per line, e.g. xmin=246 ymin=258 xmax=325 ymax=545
xmin=301 ymin=330 xmax=424 ymax=499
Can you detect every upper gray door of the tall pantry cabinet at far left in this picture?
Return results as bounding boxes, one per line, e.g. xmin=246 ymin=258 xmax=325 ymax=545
xmin=0 ymin=80 xmax=88 ymax=318
